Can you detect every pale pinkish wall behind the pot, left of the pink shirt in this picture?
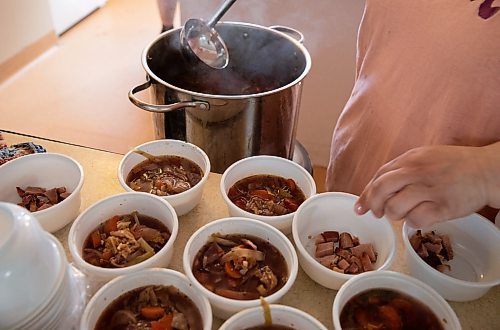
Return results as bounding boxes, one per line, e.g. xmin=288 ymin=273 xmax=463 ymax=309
xmin=180 ymin=0 xmax=365 ymax=166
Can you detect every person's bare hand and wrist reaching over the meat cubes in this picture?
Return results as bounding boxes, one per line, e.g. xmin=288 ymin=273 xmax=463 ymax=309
xmin=355 ymin=142 xmax=500 ymax=228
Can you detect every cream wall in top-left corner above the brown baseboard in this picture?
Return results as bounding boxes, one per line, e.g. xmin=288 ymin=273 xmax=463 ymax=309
xmin=0 ymin=0 xmax=53 ymax=63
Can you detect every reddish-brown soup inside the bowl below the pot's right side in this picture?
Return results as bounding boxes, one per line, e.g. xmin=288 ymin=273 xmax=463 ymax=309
xmin=227 ymin=175 xmax=306 ymax=216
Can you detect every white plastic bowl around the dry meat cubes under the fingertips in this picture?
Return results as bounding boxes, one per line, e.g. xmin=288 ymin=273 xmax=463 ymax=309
xmin=292 ymin=192 xmax=396 ymax=290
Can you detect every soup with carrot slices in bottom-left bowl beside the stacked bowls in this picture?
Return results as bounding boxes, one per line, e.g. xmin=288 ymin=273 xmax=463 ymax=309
xmin=94 ymin=285 xmax=203 ymax=330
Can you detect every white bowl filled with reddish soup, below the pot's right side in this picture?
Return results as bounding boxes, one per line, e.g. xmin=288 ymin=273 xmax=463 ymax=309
xmin=220 ymin=155 xmax=316 ymax=234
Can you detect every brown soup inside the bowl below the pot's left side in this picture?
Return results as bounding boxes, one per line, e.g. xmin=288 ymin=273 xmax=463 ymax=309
xmin=126 ymin=156 xmax=203 ymax=196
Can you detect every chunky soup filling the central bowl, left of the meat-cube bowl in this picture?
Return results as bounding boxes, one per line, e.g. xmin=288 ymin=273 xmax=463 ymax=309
xmin=193 ymin=235 xmax=288 ymax=300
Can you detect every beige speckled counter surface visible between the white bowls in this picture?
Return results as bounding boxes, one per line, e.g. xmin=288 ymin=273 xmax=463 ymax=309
xmin=3 ymin=133 xmax=500 ymax=330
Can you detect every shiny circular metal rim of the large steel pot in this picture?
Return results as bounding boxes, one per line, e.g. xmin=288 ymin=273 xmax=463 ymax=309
xmin=141 ymin=21 xmax=311 ymax=100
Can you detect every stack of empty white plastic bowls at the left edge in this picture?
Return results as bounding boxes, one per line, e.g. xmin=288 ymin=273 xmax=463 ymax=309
xmin=0 ymin=202 xmax=68 ymax=329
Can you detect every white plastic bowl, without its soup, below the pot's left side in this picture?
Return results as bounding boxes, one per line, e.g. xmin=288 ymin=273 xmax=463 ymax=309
xmin=118 ymin=139 xmax=210 ymax=216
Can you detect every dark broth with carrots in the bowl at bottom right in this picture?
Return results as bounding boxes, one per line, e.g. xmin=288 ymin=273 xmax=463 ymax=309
xmin=340 ymin=289 xmax=444 ymax=330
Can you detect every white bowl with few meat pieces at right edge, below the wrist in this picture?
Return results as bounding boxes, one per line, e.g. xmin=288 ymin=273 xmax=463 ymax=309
xmin=402 ymin=214 xmax=500 ymax=301
